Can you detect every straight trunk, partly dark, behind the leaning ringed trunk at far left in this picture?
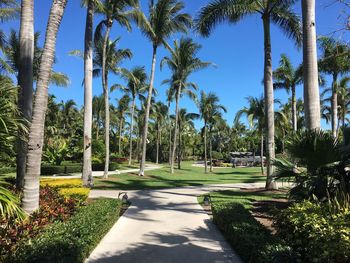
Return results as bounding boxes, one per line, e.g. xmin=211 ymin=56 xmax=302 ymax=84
xmin=16 ymin=0 xmax=34 ymax=189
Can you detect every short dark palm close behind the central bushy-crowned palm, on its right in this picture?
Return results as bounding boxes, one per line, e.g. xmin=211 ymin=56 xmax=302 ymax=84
xmin=177 ymin=109 xmax=200 ymax=170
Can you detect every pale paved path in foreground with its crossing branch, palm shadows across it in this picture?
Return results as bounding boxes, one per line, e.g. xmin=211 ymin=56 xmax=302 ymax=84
xmin=86 ymin=183 xmax=278 ymax=263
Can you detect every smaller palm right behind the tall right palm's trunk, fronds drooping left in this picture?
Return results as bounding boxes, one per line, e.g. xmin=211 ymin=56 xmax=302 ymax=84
xmin=235 ymin=97 xmax=265 ymax=174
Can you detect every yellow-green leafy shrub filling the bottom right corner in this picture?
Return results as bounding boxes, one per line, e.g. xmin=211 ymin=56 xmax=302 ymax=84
xmin=276 ymin=201 xmax=350 ymax=262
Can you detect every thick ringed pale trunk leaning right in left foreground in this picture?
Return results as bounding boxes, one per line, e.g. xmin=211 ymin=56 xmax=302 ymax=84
xmin=22 ymin=0 xmax=67 ymax=213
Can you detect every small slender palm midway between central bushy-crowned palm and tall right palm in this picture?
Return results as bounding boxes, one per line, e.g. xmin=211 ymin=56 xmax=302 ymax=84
xmin=198 ymin=91 xmax=226 ymax=173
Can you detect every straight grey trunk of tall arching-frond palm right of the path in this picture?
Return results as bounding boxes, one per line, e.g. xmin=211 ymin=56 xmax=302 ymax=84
xmin=263 ymin=16 xmax=276 ymax=189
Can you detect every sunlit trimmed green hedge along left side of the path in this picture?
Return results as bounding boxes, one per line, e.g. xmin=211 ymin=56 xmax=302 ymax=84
xmin=6 ymin=199 xmax=121 ymax=263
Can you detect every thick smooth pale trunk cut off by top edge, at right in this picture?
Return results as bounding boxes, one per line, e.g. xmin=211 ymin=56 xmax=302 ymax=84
xmin=301 ymin=0 xmax=321 ymax=130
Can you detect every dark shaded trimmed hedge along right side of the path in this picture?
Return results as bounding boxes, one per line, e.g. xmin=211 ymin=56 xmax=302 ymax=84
xmin=212 ymin=202 xmax=294 ymax=262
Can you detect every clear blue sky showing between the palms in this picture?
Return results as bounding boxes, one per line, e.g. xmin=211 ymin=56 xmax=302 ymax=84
xmin=2 ymin=0 xmax=349 ymax=130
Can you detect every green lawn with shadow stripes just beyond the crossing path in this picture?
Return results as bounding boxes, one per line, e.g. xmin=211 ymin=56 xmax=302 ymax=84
xmin=94 ymin=162 xmax=265 ymax=190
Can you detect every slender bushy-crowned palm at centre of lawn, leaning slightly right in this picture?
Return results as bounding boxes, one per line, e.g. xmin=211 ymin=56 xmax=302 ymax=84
xmin=160 ymin=38 xmax=210 ymax=174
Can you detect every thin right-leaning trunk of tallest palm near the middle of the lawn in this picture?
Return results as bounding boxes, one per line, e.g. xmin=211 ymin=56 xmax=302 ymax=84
xmin=139 ymin=45 xmax=157 ymax=176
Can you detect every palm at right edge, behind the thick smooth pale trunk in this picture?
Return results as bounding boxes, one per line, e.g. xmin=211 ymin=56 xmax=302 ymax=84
xmin=319 ymin=37 xmax=350 ymax=137
